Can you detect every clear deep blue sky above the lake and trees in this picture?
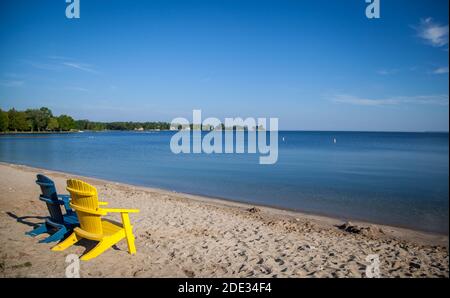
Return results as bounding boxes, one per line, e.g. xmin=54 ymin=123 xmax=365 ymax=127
xmin=0 ymin=0 xmax=449 ymax=131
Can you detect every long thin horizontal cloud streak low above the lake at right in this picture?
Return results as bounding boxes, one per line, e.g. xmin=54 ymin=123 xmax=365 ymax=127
xmin=332 ymin=94 xmax=449 ymax=106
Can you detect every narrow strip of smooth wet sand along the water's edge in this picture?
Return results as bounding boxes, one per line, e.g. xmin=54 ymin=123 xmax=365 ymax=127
xmin=0 ymin=161 xmax=449 ymax=247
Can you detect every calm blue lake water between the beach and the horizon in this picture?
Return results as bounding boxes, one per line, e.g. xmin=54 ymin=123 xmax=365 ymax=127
xmin=0 ymin=131 xmax=449 ymax=234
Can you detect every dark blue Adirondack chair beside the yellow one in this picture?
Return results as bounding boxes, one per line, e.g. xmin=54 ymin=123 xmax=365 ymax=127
xmin=26 ymin=174 xmax=79 ymax=243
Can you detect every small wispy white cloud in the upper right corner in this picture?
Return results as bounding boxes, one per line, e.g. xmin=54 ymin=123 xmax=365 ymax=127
xmin=414 ymin=18 xmax=448 ymax=47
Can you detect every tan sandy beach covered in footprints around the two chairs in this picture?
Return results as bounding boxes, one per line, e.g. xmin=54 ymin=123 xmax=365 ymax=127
xmin=0 ymin=163 xmax=449 ymax=278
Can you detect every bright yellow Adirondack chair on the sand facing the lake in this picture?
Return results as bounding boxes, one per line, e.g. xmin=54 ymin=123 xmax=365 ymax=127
xmin=52 ymin=179 xmax=139 ymax=261
